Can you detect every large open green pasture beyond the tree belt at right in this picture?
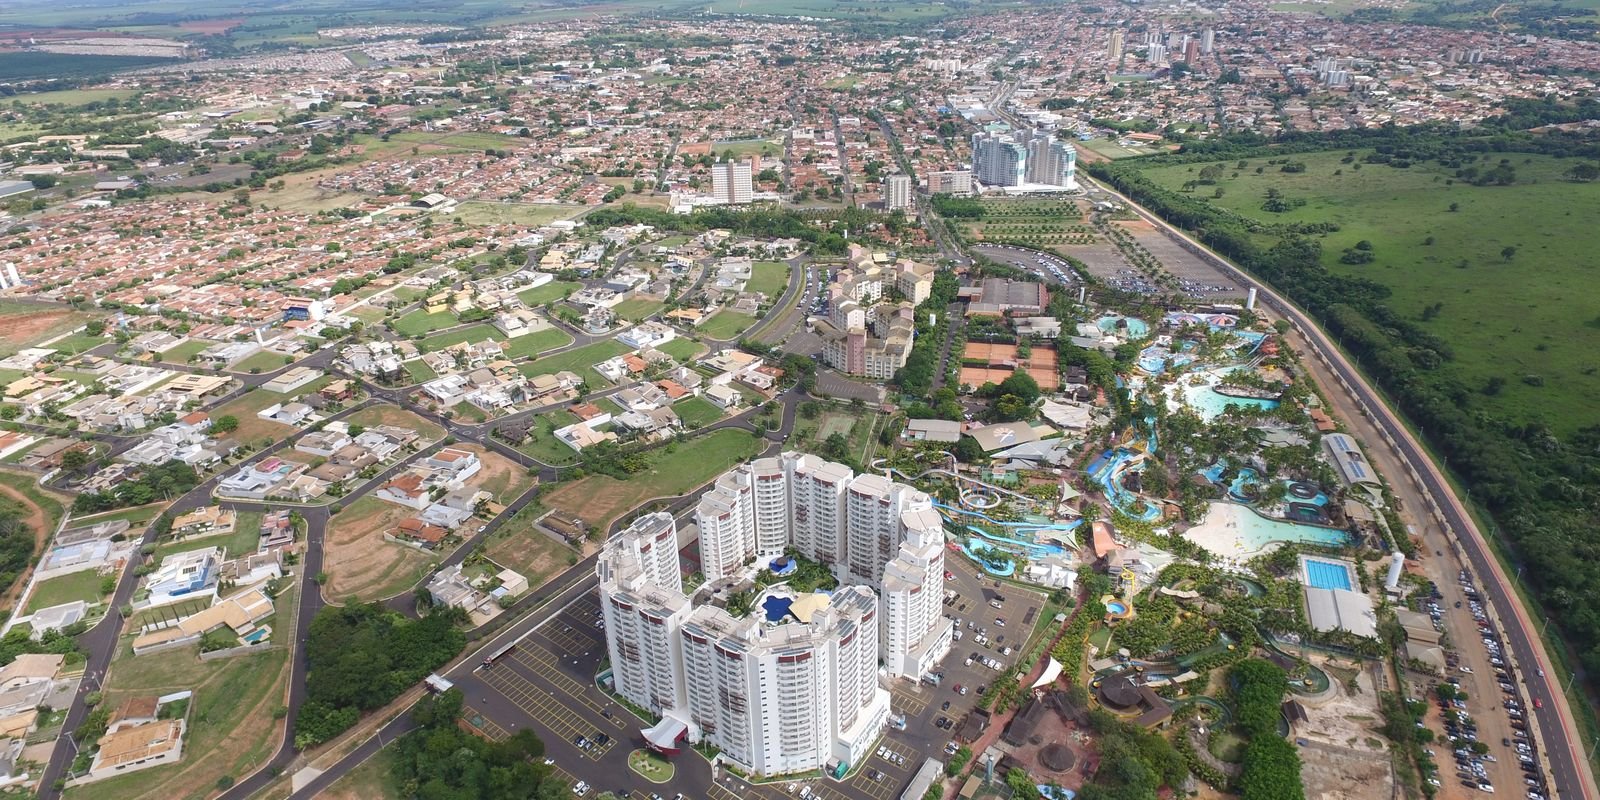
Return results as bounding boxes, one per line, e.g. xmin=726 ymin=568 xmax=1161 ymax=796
xmin=1147 ymin=150 xmax=1600 ymax=435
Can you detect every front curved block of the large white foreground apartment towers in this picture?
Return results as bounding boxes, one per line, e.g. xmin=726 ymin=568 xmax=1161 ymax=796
xmin=597 ymin=515 xmax=896 ymax=774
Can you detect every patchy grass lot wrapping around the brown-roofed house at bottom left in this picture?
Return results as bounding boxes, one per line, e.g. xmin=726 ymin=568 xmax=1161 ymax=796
xmin=64 ymin=589 xmax=296 ymax=800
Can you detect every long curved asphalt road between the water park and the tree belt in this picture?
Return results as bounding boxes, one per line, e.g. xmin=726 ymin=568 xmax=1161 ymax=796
xmin=1094 ymin=175 xmax=1597 ymax=800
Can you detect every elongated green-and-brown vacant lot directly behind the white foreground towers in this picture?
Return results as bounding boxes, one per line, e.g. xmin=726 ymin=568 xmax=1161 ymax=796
xmin=542 ymin=429 xmax=763 ymax=530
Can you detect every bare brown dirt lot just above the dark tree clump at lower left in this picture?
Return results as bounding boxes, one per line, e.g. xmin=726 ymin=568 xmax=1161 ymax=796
xmin=322 ymin=496 xmax=438 ymax=602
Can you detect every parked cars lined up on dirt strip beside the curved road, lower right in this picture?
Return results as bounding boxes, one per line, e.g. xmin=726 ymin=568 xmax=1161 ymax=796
xmin=1426 ymin=570 xmax=1546 ymax=800
